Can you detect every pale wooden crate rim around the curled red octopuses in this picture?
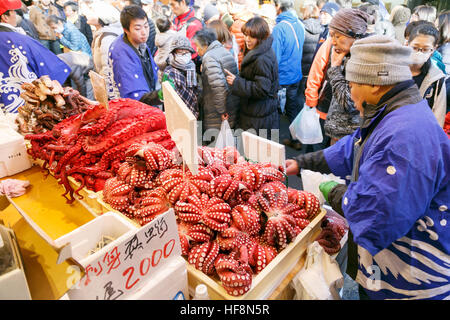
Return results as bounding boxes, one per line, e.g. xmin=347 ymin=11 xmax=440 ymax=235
xmin=187 ymin=208 xmax=326 ymax=300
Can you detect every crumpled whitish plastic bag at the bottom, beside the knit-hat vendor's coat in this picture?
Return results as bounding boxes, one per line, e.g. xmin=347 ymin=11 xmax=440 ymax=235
xmin=291 ymin=241 xmax=344 ymax=300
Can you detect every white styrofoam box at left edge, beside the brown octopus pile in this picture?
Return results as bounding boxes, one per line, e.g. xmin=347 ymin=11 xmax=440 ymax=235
xmin=0 ymin=126 xmax=31 ymax=178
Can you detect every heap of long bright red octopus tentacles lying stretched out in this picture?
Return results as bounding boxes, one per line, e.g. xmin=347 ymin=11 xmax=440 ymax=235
xmin=25 ymin=99 xmax=174 ymax=203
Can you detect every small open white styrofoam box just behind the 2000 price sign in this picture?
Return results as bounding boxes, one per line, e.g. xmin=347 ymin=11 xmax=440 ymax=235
xmin=55 ymin=212 xmax=138 ymax=267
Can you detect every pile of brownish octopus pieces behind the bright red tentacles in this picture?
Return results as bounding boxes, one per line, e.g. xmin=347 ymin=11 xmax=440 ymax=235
xmin=16 ymin=76 xmax=94 ymax=134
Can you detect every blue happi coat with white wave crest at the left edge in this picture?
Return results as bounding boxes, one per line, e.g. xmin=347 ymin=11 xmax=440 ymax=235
xmin=0 ymin=31 xmax=71 ymax=113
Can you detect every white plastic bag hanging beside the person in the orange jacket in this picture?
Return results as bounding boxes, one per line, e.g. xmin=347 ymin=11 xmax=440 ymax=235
xmin=289 ymin=104 xmax=323 ymax=144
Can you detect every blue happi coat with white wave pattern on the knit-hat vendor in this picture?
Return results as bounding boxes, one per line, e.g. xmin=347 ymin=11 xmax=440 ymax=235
xmin=324 ymin=92 xmax=450 ymax=299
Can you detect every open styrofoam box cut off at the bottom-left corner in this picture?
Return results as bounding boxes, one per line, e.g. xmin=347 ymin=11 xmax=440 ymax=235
xmin=0 ymin=225 xmax=31 ymax=300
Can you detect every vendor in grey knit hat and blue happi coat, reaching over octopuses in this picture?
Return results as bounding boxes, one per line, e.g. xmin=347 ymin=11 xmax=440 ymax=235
xmin=286 ymin=35 xmax=450 ymax=300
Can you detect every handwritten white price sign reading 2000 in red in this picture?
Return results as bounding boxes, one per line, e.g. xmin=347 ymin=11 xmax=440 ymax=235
xmin=69 ymin=209 xmax=181 ymax=300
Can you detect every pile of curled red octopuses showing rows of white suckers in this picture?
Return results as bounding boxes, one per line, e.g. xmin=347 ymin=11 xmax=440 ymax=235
xmin=103 ymin=143 xmax=320 ymax=296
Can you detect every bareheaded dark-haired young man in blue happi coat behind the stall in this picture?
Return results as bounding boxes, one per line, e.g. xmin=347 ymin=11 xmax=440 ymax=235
xmin=107 ymin=5 xmax=160 ymax=102
